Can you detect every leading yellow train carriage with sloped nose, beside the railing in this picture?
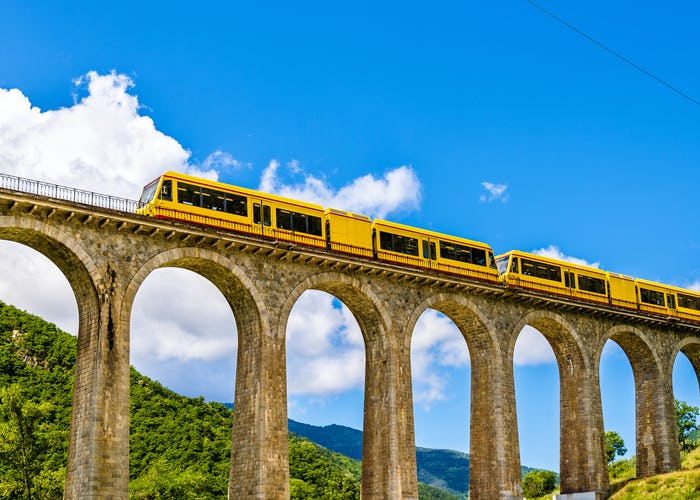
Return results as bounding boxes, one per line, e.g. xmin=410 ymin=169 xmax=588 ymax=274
xmin=137 ymin=172 xmax=326 ymax=248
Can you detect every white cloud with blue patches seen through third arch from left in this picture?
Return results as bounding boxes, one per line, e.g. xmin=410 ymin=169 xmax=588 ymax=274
xmin=287 ymin=290 xmax=365 ymax=396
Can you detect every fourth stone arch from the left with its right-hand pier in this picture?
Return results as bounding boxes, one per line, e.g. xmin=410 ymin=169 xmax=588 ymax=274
xmin=403 ymin=293 xmax=522 ymax=499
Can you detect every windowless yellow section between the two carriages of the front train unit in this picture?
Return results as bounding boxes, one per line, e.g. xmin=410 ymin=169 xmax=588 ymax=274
xmin=324 ymin=208 xmax=373 ymax=258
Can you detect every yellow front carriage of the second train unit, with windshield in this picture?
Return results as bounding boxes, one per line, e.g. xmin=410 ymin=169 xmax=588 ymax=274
xmin=496 ymin=250 xmax=609 ymax=303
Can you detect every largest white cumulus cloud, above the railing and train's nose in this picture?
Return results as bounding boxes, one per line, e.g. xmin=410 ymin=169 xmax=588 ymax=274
xmin=0 ymin=71 xmax=219 ymax=199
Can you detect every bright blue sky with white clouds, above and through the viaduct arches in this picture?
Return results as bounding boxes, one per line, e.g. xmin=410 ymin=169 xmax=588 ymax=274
xmin=0 ymin=0 xmax=700 ymax=470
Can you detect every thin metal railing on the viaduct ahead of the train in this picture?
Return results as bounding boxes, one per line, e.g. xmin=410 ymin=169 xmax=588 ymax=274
xmin=0 ymin=173 xmax=139 ymax=213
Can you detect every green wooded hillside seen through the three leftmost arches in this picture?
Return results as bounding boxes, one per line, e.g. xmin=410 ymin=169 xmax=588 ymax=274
xmin=0 ymin=302 xmax=360 ymax=500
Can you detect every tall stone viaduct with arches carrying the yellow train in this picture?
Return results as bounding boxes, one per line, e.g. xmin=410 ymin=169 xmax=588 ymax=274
xmin=0 ymin=175 xmax=700 ymax=500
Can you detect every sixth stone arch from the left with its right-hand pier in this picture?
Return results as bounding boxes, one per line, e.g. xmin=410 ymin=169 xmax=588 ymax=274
xmin=595 ymin=325 xmax=680 ymax=478
